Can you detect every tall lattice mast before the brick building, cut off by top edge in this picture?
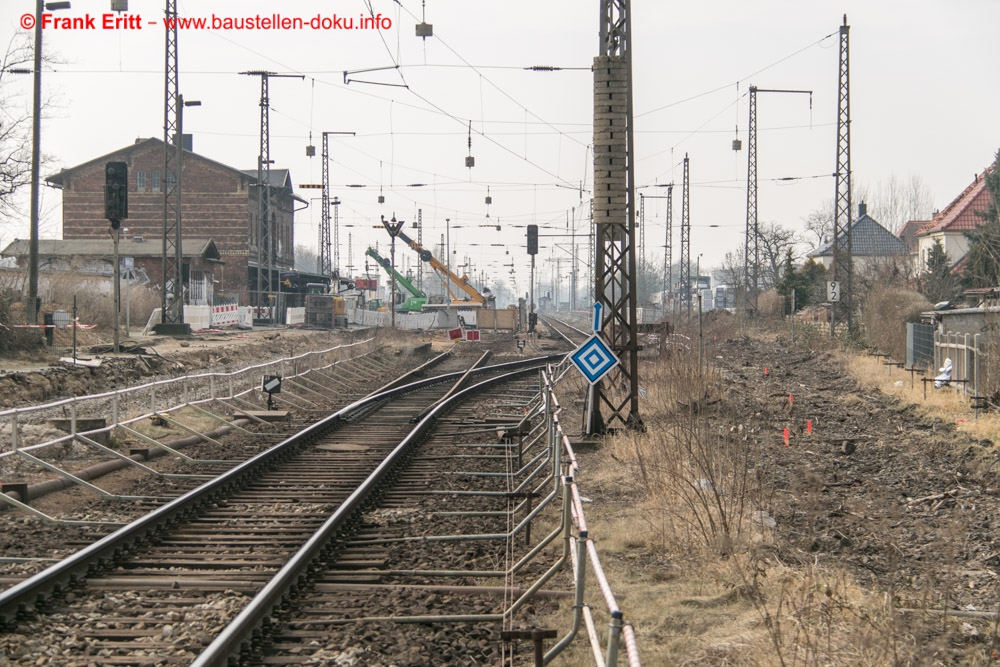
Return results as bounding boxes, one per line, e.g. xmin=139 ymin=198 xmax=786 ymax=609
xmin=160 ymin=0 xmax=184 ymax=325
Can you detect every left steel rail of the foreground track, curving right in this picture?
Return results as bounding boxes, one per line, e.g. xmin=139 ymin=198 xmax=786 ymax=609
xmin=0 ymin=357 xmax=564 ymax=631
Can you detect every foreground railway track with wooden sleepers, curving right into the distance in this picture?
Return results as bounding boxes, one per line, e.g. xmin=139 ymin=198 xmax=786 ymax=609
xmin=0 ymin=352 xmax=558 ymax=665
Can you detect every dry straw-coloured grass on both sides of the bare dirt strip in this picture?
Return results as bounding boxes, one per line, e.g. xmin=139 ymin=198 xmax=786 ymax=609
xmin=539 ymin=337 xmax=997 ymax=667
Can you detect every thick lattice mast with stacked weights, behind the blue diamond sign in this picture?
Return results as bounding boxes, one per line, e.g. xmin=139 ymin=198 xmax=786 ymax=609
xmin=587 ymin=0 xmax=642 ymax=432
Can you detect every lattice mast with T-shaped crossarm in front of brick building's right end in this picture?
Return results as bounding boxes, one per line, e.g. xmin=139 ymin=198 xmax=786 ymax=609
xmin=240 ymin=70 xmax=305 ymax=322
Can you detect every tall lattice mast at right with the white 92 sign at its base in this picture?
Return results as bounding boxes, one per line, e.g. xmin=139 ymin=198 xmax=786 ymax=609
xmin=830 ymin=14 xmax=854 ymax=334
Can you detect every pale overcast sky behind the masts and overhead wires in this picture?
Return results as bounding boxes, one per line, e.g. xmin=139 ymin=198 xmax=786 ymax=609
xmin=0 ymin=0 xmax=1000 ymax=298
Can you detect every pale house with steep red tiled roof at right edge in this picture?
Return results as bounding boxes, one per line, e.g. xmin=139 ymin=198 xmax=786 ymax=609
xmin=907 ymin=165 xmax=992 ymax=272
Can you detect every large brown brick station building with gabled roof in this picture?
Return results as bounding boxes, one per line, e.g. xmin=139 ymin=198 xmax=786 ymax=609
xmin=45 ymin=138 xmax=306 ymax=305
